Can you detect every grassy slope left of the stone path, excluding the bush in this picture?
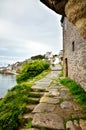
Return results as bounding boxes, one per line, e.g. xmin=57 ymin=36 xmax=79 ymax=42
xmin=0 ymin=70 xmax=50 ymax=130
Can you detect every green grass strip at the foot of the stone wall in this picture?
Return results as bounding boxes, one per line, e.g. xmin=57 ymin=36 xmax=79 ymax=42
xmin=60 ymin=78 xmax=86 ymax=111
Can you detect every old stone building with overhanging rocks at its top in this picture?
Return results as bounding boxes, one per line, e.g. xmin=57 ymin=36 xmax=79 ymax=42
xmin=40 ymin=0 xmax=86 ymax=91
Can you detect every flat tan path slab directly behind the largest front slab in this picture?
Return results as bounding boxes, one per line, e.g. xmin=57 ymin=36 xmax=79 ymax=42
xmin=33 ymin=103 xmax=55 ymax=113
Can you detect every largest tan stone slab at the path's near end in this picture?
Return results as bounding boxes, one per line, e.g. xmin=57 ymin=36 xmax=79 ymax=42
xmin=32 ymin=113 xmax=65 ymax=130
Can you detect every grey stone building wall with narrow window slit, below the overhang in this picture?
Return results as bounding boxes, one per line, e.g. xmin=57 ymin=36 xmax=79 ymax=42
xmin=63 ymin=18 xmax=86 ymax=91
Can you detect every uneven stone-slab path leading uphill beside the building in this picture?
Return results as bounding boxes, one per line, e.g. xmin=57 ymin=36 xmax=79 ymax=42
xmin=20 ymin=65 xmax=86 ymax=130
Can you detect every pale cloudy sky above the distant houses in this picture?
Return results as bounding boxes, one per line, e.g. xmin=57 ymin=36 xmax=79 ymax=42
xmin=0 ymin=0 xmax=62 ymax=62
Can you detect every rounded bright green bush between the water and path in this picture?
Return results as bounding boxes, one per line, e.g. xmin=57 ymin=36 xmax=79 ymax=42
xmin=16 ymin=60 xmax=49 ymax=83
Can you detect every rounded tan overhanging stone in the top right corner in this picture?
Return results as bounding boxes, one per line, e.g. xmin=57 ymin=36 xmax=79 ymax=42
xmin=65 ymin=0 xmax=86 ymax=39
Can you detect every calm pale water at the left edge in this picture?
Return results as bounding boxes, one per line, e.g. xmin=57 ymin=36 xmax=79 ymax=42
xmin=0 ymin=74 xmax=16 ymax=98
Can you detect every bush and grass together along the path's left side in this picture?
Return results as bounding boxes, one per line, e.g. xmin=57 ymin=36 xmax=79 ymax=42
xmin=0 ymin=61 xmax=50 ymax=130
